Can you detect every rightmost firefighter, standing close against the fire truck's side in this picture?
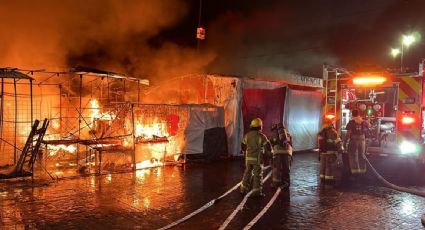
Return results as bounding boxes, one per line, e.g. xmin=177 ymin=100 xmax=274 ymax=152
xmin=346 ymin=109 xmax=370 ymax=179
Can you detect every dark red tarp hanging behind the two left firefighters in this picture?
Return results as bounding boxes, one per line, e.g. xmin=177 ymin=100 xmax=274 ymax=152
xmin=242 ymin=87 xmax=286 ymax=135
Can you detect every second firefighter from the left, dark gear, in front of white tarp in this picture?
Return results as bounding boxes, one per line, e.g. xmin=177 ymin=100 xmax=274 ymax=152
xmin=271 ymin=123 xmax=292 ymax=189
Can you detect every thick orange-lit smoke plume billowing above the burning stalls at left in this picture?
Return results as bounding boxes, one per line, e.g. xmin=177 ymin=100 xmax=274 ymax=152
xmin=0 ymin=0 xmax=213 ymax=80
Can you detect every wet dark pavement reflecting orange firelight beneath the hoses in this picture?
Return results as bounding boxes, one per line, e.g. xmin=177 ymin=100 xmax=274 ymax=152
xmin=0 ymin=153 xmax=425 ymax=229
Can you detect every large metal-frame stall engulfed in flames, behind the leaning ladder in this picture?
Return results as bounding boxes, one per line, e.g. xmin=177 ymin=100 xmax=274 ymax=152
xmin=33 ymin=67 xmax=152 ymax=176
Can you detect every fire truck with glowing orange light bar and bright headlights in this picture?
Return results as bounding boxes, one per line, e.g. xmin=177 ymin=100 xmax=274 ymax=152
xmin=323 ymin=62 xmax=425 ymax=166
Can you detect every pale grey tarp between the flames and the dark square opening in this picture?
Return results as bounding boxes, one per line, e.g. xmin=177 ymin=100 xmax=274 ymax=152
xmin=183 ymin=106 xmax=224 ymax=154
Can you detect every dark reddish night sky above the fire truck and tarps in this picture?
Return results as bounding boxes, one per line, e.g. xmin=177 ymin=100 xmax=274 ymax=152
xmin=159 ymin=0 xmax=425 ymax=76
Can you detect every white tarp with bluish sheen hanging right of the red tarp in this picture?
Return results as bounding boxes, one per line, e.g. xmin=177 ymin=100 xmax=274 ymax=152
xmin=284 ymin=88 xmax=322 ymax=151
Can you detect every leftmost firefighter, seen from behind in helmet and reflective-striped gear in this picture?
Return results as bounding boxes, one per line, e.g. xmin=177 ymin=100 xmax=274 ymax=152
xmin=240 ymin=118 xmax=271 ymax=196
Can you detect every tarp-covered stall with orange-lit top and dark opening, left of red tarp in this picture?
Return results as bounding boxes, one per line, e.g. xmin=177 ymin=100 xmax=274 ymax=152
xmin=143 ymin=74 xmax=243 ymax=159
